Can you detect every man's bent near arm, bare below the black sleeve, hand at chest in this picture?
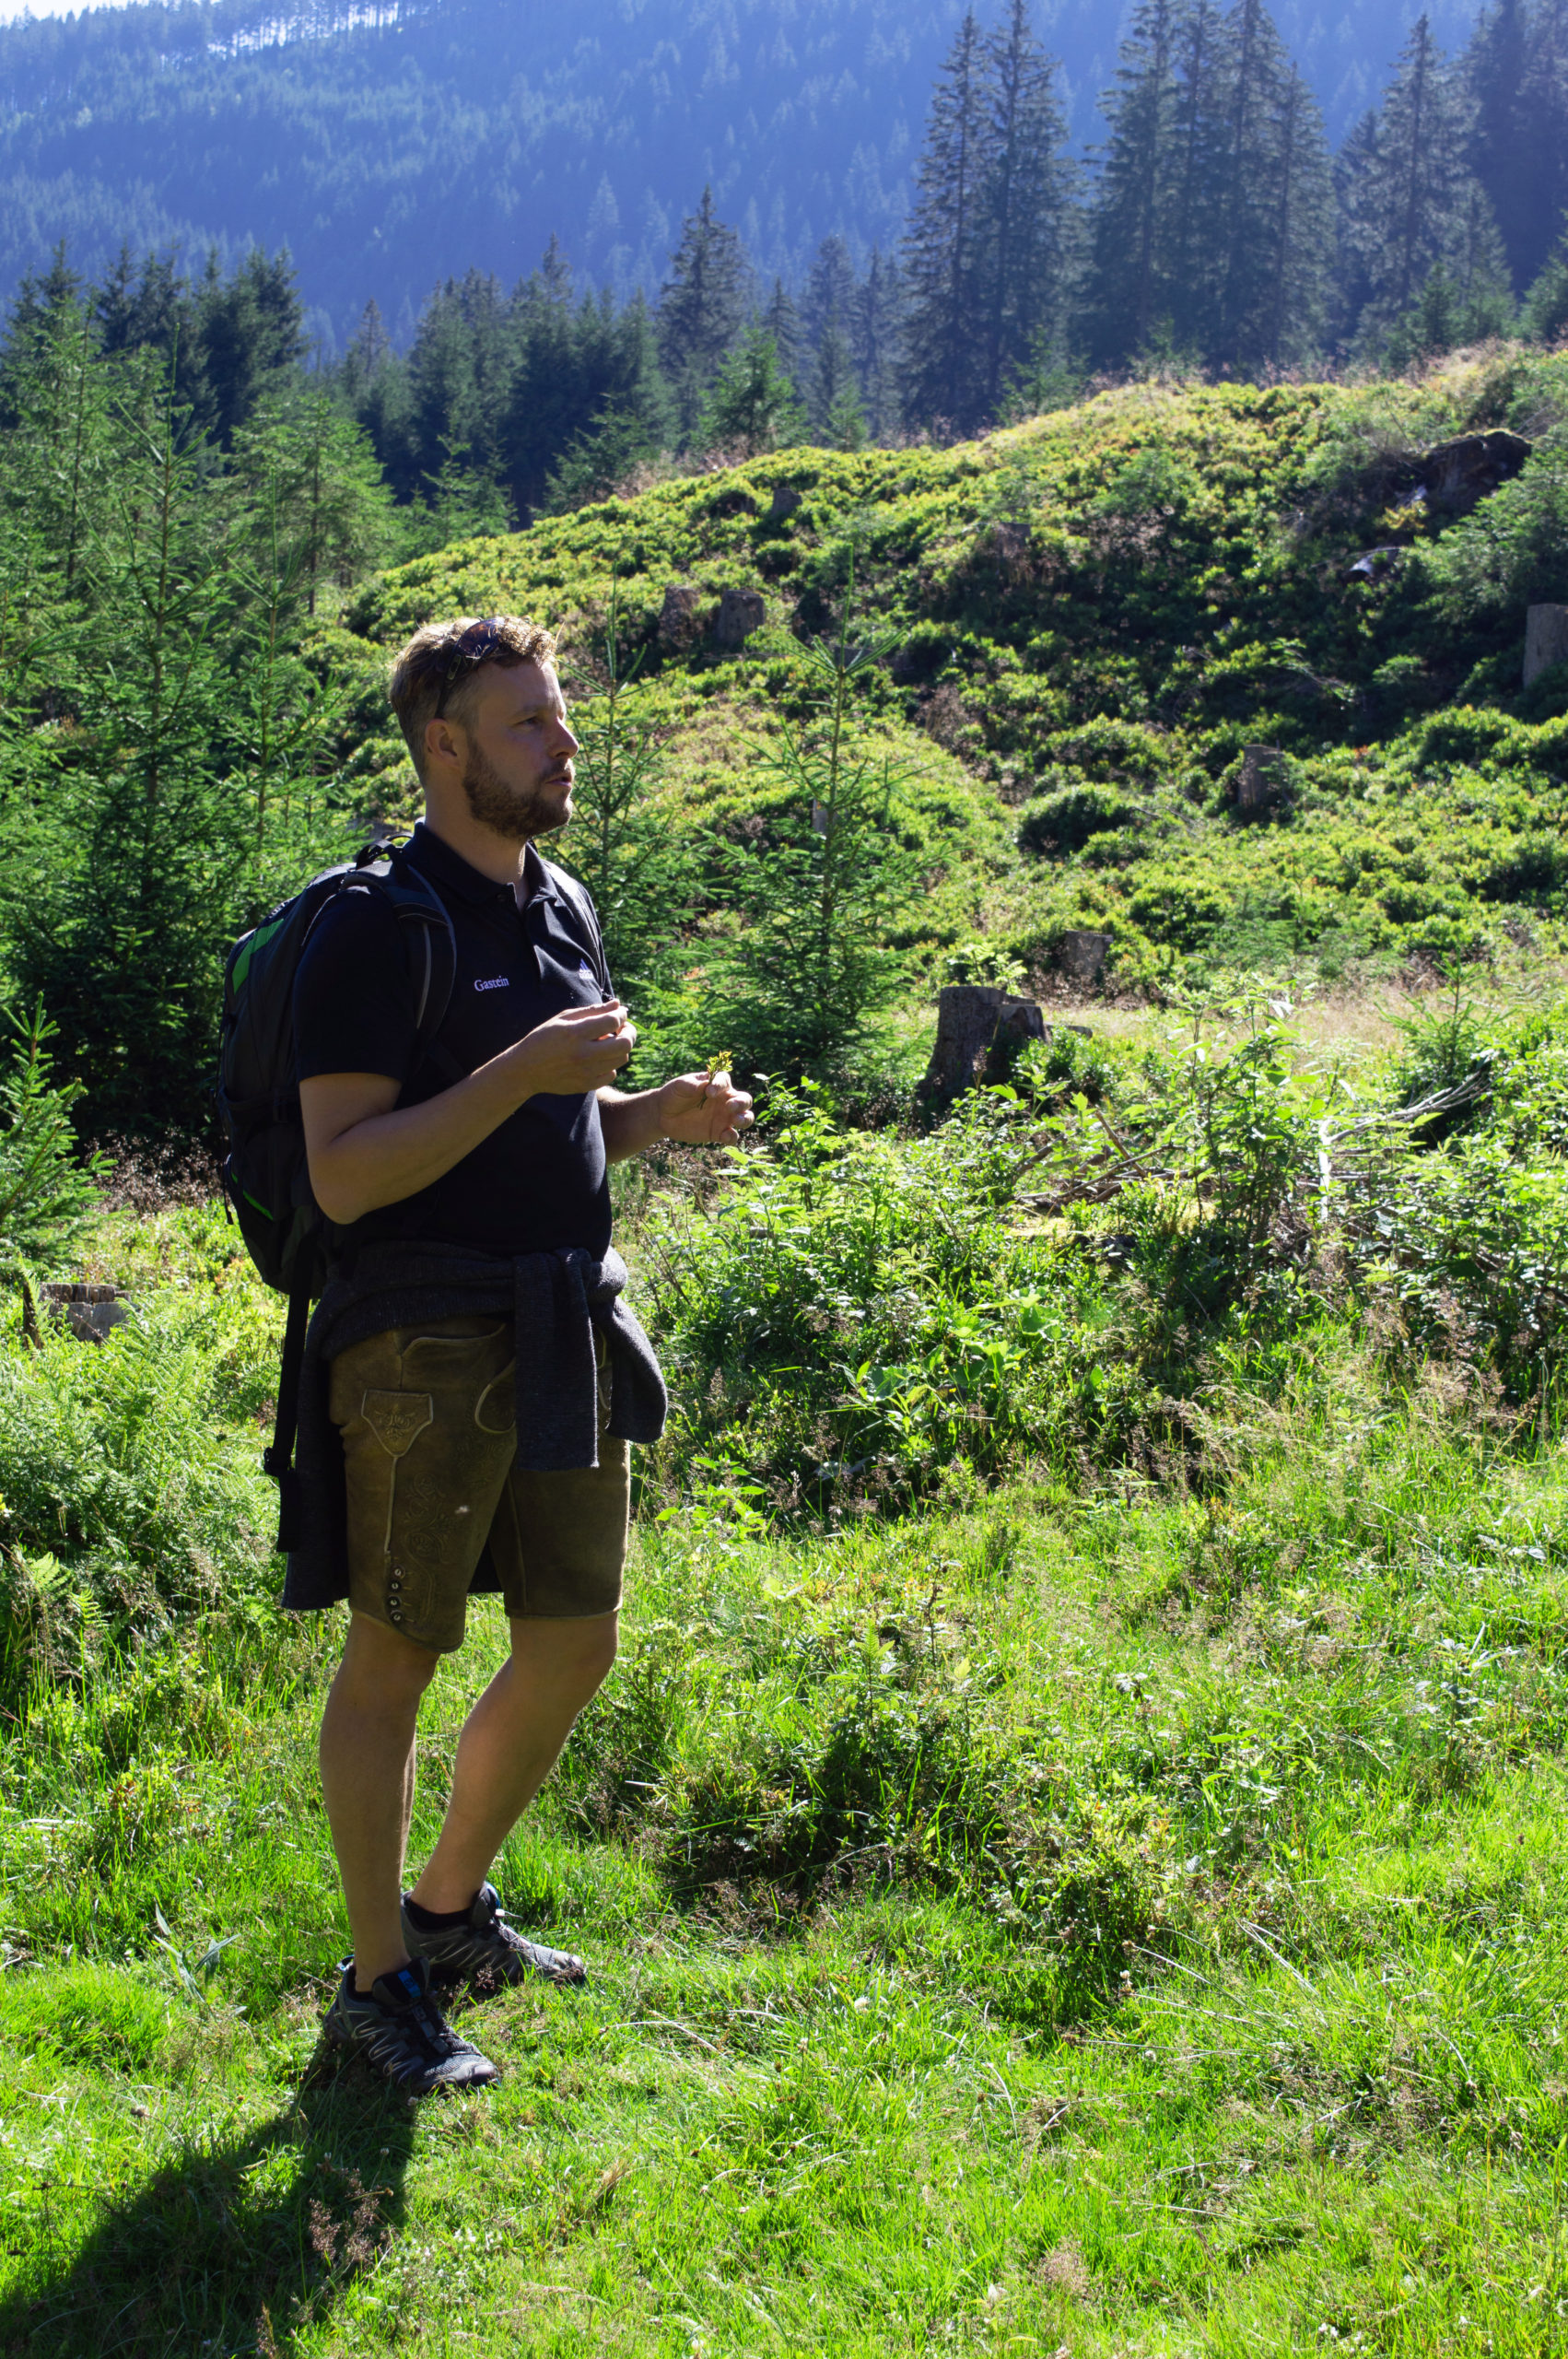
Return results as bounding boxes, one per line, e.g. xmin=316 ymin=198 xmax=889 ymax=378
xmin=299 ymin=1000 xmax=631 ymax=1226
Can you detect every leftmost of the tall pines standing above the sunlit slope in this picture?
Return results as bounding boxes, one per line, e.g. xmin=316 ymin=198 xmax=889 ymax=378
xmin=903 ymin=9 xmax=986 ymax=434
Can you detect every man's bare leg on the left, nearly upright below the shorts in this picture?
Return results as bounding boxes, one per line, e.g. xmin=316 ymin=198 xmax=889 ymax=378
xmin=321 ymin=1614 xmax=441 ymax=1991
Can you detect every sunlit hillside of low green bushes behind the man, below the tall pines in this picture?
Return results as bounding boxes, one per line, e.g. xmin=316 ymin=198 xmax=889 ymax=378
xmin=328 ymin=357 xmax=1568 ymax=984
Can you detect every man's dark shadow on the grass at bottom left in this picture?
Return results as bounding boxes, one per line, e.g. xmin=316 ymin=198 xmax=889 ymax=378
xmin=0 ymin=2050 xmax=429 ymax=2359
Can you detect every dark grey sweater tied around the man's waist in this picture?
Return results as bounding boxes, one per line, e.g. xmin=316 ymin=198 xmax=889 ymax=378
xmin=283 ymin=1241 xmax=667 ymax=1614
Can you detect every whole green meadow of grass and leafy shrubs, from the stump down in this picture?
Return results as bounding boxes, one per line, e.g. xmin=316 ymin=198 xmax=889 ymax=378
xmin=0 ymin=974 xmax=1568 ymax=2359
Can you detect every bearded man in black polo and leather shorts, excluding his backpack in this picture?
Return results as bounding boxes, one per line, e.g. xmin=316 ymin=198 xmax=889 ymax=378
xmin=286 ymin=616 xmax=752 ymax=2090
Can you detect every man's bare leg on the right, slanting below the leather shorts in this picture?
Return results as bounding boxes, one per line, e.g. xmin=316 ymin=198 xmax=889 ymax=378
xmin=410 ymin=1614 xmax=620 ymax=1939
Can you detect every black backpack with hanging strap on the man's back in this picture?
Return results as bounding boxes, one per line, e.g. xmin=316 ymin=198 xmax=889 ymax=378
xmin=215 ymin=842 xmax=458 ymax=1550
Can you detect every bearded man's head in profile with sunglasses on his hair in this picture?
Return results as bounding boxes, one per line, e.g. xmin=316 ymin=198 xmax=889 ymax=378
xmin=389 ymin=614 xmax=578 ymax=842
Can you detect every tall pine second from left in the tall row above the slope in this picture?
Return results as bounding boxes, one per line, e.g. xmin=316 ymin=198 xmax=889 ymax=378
xmin=983 ymin=0 xmax=1068 ymax=416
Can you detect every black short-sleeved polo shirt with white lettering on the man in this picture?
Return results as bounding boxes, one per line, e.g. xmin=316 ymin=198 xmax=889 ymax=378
xmin=295 ymin=823 xmax=613 ymax=1255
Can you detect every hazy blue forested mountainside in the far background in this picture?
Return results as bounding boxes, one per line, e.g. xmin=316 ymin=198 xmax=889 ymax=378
xmin=0 ymin=0 xmax=1476 ymax=357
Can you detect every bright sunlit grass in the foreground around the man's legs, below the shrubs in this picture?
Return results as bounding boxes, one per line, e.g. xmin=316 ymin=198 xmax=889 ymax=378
xmin=0 ymin=1328 xmax=1568 ymax=2359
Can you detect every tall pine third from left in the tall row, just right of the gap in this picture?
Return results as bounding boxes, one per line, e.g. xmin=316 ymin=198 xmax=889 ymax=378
xmin=1084 ymin=0 xmax=1179 ymax=363
